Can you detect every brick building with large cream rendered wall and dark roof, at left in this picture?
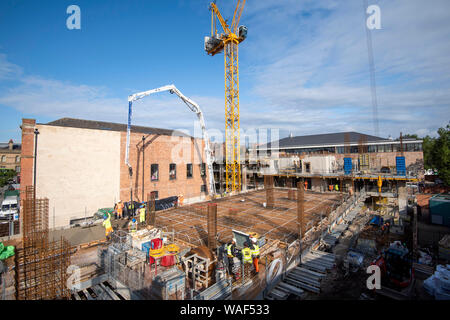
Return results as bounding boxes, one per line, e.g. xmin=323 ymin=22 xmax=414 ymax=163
xmin=21 ymin=118 xmax=208 ymax=227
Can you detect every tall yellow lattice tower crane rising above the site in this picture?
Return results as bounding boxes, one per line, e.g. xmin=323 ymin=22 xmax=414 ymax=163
xmin=205 ymin=0 xmax=247 ymax=192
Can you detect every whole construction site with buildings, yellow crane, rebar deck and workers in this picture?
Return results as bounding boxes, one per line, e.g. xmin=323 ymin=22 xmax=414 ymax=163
xmin=0 ymin=0 xmax=450 ymax=301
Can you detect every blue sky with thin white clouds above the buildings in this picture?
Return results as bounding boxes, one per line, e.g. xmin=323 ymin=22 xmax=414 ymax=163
xmin=0 ymin=0 xmax=450 ymax=141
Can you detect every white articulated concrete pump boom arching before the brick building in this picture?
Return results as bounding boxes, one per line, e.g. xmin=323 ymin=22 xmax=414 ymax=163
xmin=125 ymin=84 xmax=216 ymax=196
